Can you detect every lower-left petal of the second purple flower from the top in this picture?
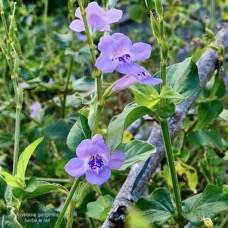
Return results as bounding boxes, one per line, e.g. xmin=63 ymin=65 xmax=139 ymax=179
xmin=95 ymin=55 xmax=116 ymax=73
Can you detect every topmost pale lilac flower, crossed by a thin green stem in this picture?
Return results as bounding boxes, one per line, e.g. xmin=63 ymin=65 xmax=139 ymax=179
xmin=70 ymin=2 xmax=123 ymax=33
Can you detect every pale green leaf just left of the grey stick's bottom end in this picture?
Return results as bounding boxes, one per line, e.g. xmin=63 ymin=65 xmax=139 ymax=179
xmin=86 ymin=195 xmax=114 ymax=221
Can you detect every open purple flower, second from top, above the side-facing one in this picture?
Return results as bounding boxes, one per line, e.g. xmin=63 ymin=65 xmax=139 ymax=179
xmin=95 ymin=33 xmax=151 ymax=74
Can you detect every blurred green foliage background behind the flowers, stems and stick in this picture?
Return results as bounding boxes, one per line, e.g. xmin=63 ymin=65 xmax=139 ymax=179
xmin=0 ymin=0 xmax=228 ymax=227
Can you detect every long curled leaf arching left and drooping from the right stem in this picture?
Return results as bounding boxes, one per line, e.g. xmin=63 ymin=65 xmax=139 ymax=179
xmin=107 ymin=102 xmax=153 ymax=152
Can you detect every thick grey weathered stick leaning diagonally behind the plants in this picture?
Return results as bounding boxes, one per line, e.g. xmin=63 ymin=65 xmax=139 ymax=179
xmin=102 ymin=23 xmax=228 ymax=228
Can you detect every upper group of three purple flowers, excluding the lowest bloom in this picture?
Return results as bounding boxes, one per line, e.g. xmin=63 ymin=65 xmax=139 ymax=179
xmin=70 ymin=2 xmax=162 ymax=92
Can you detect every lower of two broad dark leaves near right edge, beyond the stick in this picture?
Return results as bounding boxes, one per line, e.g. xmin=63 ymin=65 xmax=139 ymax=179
xmin=188 ymin=126 xmax=223 ymax=149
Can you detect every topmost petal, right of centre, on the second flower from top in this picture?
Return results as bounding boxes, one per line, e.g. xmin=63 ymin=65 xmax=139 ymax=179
xmin=112 ymin=33 xmax=132 ymax=55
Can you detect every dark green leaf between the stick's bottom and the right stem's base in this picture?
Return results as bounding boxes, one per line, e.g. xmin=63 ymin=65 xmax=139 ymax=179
xmin=136 ymin=188 xmax=175 ymax=225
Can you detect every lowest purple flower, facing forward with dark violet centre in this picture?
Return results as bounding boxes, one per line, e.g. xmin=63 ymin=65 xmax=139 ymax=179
xmin=64 ymin=134 xmax=125 ymax=185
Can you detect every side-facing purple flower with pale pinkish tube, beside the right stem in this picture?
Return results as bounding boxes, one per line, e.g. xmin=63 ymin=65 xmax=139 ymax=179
xmin=112 ymin=64 xmax=162 ymax=93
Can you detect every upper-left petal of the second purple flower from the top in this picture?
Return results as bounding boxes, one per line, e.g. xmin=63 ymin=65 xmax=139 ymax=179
xmin=98 ymin=36 xmax=116 ymax=59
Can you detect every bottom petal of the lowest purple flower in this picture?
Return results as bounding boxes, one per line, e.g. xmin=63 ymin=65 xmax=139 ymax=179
xmin=86 ymin=166 xmax=111 ymax=185
